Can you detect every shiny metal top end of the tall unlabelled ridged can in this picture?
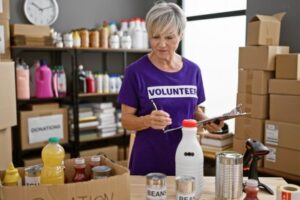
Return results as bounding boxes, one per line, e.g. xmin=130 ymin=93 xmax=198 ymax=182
xmin=216 ymin=151 xmax=243 ymax=165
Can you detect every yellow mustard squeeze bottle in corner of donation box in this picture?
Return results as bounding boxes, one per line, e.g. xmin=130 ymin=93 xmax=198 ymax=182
xmin=3 ymin=163 xmax=22 ymax=186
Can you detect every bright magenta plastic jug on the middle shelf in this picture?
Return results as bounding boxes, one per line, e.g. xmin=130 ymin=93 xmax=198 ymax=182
xmin=35 ymin=60 xmax=53 ymax=98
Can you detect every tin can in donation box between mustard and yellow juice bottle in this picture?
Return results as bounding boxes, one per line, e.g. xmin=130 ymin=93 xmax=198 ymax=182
xmin=25 ymin=165 xmax=42 ymax=185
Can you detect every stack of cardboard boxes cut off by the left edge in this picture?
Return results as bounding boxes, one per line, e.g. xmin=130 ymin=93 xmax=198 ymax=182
xmin=0 ymin=0 xmax=16 ymax=169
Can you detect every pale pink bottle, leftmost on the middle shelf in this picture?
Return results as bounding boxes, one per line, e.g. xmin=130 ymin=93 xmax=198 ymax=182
xmin=16 ymin=59 xmax=30 ymax=99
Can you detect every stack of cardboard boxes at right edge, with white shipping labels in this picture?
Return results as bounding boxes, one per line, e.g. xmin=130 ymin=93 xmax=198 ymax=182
xmin=264 ymin=54 xmax=300 ymax=177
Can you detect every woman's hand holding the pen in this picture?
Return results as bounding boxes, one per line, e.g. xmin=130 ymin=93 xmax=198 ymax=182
xmin=147 ymin=110 xmax=172 ymax=129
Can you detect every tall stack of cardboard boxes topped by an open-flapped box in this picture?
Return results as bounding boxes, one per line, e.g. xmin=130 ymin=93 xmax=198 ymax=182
xmin=233 ymin=13 xmax=289 ymax=153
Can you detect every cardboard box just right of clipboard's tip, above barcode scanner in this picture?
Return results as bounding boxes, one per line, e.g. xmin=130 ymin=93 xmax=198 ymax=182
xmin=234 ymin=117 xmax=265 ymax=142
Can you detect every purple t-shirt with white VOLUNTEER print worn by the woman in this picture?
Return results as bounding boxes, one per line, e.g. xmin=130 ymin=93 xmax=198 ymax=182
xmin=118 ymin=55 xmax=205 ymax=175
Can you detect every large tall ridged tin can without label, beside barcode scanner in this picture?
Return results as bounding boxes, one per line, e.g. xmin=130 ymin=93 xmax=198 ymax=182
xmin=215 ymin=152 xmax=243 ymax=200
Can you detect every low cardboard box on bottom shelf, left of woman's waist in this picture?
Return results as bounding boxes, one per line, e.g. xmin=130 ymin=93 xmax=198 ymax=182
xmin=80 ymin=145 xmax=119 ymax=161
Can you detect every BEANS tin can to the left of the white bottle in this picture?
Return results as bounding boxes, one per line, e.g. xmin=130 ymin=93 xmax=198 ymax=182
xmin=146 ymin=173 xmax=167 ymax=200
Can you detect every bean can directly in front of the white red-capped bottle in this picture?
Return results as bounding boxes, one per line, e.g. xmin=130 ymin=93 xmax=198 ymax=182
xmin=176 ymin=176 xmax=196 ymax=200
